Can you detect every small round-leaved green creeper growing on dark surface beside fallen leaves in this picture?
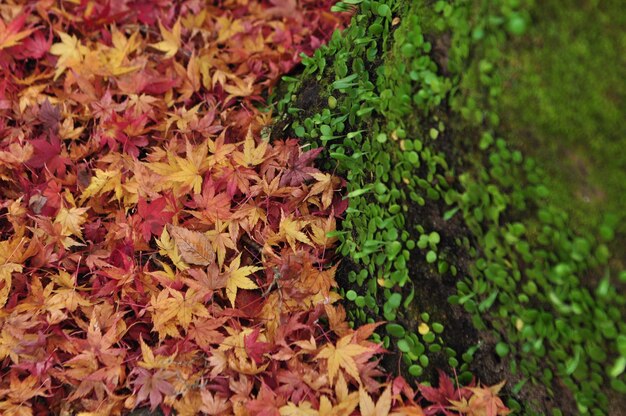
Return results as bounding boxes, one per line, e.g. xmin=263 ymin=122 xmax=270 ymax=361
xmin=277 ymin=0 xmax=626 ymax=414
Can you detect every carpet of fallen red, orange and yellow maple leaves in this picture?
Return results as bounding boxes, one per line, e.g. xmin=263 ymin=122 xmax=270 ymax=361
xmin=0 ymin=0 xmax=508 ymax=415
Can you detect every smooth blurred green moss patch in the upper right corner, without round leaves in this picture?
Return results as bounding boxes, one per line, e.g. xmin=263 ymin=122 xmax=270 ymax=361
xmin=497 ymin=1 xmax=626 ymax=239
